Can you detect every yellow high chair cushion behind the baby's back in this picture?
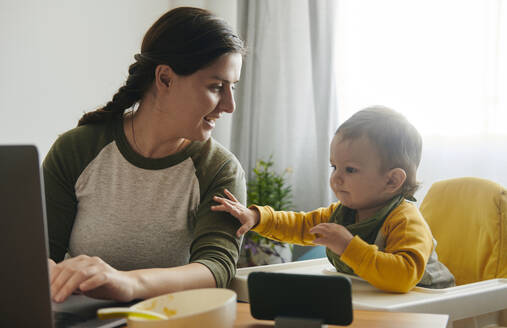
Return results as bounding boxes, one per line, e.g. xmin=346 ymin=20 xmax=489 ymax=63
xmin=420 ymin=177 xmax=507 ymax=285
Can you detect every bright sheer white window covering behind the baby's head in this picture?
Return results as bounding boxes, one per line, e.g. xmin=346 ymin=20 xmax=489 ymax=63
xmin=335 ymin=0 xmax=507 ymax=201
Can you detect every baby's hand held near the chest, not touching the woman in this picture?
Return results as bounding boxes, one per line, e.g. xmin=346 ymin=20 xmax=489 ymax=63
xmin=310 ymin=223 xmax=354 ymax=255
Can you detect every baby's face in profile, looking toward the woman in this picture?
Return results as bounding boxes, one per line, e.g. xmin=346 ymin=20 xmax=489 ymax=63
xmin=330 ymin=134 xmax=390 ymax=219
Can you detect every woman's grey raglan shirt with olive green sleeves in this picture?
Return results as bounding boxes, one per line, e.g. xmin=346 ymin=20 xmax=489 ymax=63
xmin=43 ymin=119 xmax=246 ymax=287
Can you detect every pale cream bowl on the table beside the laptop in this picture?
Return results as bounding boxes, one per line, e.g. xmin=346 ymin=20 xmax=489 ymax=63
xmin=128 ymin=288 xmax=236 ymax=328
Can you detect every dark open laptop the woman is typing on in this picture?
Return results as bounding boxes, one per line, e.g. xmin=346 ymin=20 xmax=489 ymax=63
xmin=0 ymin=145 xmax=132 ymax=328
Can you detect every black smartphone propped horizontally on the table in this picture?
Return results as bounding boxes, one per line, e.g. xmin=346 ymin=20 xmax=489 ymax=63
xmin=248 ymin=272 xmax=353 ymax=325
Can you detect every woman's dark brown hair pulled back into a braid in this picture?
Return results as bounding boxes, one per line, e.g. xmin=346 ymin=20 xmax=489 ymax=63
xmin=78 ymin=7 xmax=245 ymax=126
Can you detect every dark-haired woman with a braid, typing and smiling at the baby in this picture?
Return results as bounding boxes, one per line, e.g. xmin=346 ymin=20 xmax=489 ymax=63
xmin=43 ymin=7 xmax=246 ymax=302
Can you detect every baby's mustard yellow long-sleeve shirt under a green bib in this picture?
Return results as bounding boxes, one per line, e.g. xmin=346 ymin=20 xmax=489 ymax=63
xmin=253 ymin=201 xmax=446 ymax=292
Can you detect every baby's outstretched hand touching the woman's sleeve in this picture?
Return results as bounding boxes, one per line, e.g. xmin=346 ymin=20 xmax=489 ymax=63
xmin=211 ymin=189 xmax=260 ymax=237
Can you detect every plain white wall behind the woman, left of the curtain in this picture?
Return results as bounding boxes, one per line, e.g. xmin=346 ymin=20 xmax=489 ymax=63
xmin=0 ymin=0 xmax=236 ymax=162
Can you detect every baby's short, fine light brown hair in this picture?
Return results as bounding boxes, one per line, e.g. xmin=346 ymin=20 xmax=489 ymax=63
xmin=336 ymin=106 xmax=422 ymax=197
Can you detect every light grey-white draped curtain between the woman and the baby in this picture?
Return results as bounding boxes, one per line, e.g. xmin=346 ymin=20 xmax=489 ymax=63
xmin=231 ymin=0 xmax=337 ymax=210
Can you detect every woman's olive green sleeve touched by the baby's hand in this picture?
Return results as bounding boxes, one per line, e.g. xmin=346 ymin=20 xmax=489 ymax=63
xmin=190 ymin=141 xmax=246 ymax=288
